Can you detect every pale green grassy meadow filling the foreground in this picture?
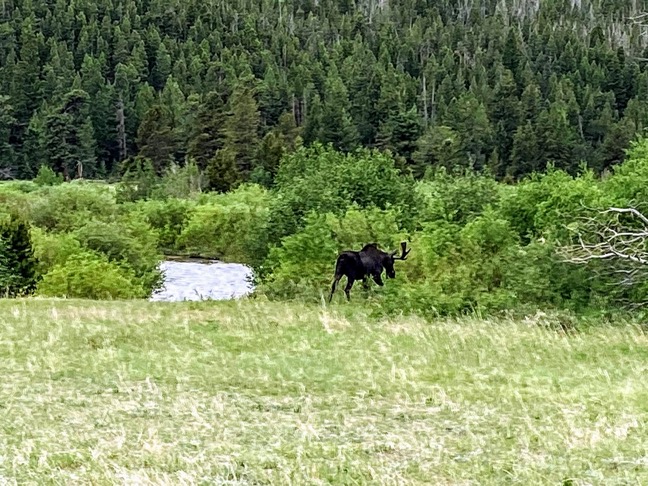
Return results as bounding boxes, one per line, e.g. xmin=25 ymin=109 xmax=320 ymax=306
xmin=0 ymin=300 xmax=648 ymax=485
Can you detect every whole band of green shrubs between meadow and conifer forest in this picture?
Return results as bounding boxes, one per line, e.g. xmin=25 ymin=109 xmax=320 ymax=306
xmin=0 ymin=140 xmax=648 ymax=315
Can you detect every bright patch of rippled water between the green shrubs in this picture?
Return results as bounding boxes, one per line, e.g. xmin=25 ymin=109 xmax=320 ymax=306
xmin=151 ymin=261 xmax=253 ymax=302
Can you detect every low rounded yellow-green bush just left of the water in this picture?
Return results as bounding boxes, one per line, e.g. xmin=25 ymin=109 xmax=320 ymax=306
xmin=37 ymin=251 xmax=149 ymax=299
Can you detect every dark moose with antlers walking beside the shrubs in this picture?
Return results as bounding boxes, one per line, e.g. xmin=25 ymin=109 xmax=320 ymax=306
xmin=329 ymin=241 xmax=411 ymax=302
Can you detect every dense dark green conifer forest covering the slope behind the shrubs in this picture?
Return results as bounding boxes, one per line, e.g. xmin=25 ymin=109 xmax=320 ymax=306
xmin=0 ymin=0 xmax=648 ymax=190
